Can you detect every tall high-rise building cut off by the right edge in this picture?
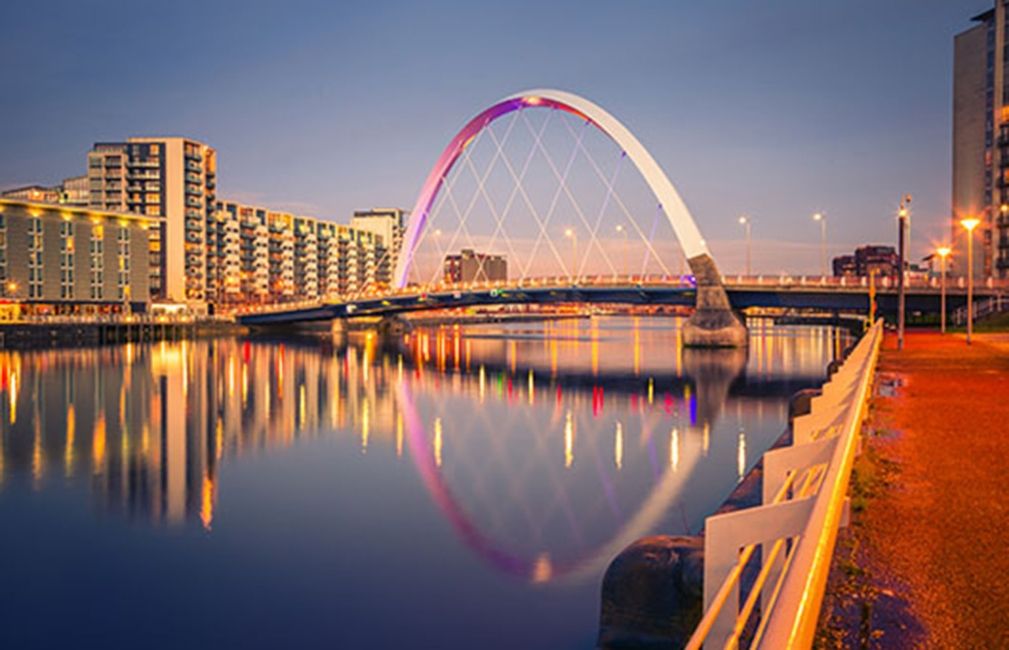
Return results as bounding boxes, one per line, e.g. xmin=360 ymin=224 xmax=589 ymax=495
xmin=950 ymin=0 xmax=1009 ymax=278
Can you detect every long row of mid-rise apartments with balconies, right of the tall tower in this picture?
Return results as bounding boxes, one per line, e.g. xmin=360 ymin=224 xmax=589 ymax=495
xmin=214 ymin=201 xmax=393 ymax=305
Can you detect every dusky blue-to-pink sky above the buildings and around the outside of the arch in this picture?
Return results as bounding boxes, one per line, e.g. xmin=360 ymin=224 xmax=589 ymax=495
xmin=0 ymin=0 xmax=991 ymax=273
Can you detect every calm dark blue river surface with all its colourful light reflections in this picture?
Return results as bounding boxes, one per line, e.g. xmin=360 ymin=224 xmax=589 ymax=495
xmin=0 ymin=317 xmax=848 ymax=649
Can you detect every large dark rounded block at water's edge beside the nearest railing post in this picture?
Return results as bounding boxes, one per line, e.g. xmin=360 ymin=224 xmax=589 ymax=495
xmin=598 ymin=535 xmax=704 ymax=650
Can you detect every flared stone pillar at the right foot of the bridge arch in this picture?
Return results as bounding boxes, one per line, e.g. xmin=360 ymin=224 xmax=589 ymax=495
xmin=683 ymin=253 xmax=749 ymax=347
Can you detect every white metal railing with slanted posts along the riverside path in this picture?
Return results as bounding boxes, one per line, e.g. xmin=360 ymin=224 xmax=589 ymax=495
xmin=687 ymin=321 xmax=883 ymax=650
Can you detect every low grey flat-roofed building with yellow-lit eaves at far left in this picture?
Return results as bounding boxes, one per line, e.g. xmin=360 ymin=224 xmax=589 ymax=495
xmin=0 ymin=199 xmax=161 ymax=314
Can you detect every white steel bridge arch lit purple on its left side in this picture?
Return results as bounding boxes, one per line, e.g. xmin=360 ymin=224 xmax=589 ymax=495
xmin=393 ymin=89 xmax=710 ymax=289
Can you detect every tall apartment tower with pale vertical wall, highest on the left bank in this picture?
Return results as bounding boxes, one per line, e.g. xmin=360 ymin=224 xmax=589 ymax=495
xmin=88 ymin=137 xmax=218 ymax=303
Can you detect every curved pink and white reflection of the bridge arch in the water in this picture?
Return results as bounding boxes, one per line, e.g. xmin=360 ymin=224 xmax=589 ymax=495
xmin=396 ymin=383 xmax=697 ymax=581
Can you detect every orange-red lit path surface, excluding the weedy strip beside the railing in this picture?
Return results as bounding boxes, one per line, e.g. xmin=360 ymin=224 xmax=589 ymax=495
xmin=859 ymin=333 xmax=1009 ymax=648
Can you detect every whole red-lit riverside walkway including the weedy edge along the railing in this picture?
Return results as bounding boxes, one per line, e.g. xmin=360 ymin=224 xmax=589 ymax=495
xmin=818 ymin=331 xmax=1009 ymax=648
